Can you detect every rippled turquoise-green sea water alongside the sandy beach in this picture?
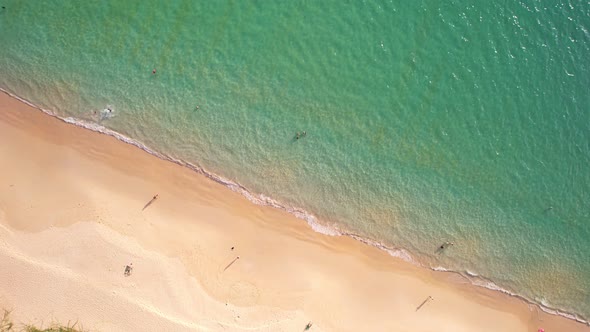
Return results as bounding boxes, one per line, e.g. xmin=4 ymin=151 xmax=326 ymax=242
xmin=0 ymin=0 xmax=590 ymax=319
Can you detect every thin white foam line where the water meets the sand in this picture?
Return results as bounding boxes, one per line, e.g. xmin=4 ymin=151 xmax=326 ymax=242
xmin=0 ymin=88 xmax=590 ymax=326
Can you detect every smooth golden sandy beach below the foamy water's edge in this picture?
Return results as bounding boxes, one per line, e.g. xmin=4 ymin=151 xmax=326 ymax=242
xmin=0 ymin=89 xmax=590 ymax=332
